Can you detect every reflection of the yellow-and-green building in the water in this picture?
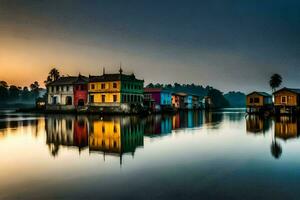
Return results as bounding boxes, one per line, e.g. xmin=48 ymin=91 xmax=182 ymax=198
xmin=89 ymin=117 xmax=144 ymax=162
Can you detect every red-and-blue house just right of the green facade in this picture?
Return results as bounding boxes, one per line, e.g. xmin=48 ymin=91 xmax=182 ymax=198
xmin=144 ymin=88 xmax=172 ymax=111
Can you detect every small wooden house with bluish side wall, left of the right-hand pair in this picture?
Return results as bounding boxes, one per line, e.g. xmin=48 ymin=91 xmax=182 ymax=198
xmin=246 ymin=92 xmax=272 ymax=113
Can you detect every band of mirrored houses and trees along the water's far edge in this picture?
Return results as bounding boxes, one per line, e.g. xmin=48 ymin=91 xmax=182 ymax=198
xmin=0 ymin=111 xmax=300 ymax=163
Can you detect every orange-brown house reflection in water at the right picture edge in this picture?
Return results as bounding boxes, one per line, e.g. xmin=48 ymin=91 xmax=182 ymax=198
xmin=275 ymin=116 xmax=300 ymax=140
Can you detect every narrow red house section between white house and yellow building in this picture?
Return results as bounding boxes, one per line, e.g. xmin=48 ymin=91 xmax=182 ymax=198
xmin=73 ymin=74 xmax=88 ymax=108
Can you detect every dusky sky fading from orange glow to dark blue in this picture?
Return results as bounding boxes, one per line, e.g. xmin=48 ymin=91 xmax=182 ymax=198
xmin=0 ymin=0 xmax=300 ymax=92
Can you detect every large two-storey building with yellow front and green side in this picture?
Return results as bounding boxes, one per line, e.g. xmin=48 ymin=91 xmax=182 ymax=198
xmin=88 ymin=69 xmax=144 ymax=110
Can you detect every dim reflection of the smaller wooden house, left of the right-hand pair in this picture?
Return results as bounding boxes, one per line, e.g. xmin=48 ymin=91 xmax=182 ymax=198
xmin=246 ymin=115 xmax=270 ymax=133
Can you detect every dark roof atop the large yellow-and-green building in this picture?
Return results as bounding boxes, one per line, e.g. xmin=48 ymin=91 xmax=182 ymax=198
xmin=89 ymin=73 xmax=143 ymax=82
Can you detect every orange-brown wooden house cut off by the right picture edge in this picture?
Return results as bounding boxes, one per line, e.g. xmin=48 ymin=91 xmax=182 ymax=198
xmin=273 ymin=88 xmax=300 ymax=114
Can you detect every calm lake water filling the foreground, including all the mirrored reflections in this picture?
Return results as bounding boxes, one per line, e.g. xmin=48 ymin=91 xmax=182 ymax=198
xmin=0 ymin=110 xmax=300 ymax=199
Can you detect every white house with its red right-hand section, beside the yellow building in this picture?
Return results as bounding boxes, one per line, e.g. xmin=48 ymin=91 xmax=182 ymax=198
xmin=46 ymin=75 xmax=88 ymax=110
